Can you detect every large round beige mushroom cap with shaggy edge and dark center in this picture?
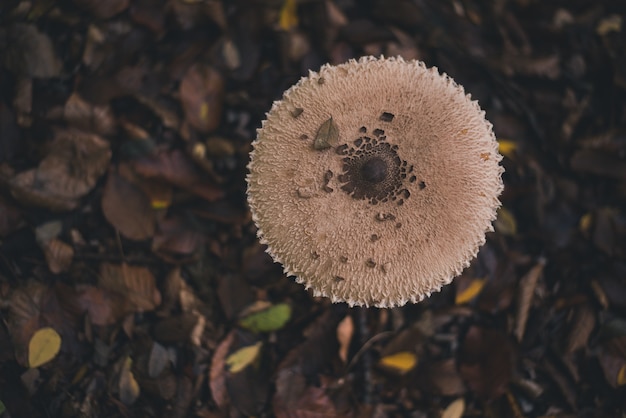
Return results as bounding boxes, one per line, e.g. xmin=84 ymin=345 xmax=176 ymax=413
xmin=247 ymin=57 xmax=503 ymax=307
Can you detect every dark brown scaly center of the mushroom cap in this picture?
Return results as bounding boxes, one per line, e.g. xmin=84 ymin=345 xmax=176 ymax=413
xmin=336 ymin=128 xmax=415 ymax=205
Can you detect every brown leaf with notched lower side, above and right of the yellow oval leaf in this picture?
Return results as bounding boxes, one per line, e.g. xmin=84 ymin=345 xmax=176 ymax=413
xmin=98 ymin=263 xmax=161 ymax=312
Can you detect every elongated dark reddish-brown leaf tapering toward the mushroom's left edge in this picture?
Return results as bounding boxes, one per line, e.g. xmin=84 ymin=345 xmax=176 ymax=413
xmin=133 ymin=150 xmax=224 ymax=201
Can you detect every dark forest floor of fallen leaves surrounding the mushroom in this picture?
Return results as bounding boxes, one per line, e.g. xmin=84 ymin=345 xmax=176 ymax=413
xmin=0 ymin=0 xmax=626 ymax=418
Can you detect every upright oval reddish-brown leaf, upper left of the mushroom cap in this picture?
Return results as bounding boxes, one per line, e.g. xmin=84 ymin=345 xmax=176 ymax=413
xmin=180 ymin=64 xmax=224 ymax=133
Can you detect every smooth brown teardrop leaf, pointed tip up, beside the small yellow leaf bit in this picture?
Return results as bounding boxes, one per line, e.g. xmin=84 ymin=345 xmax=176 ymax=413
xmin=102 ymin=170 xmax=155 ymax=240
